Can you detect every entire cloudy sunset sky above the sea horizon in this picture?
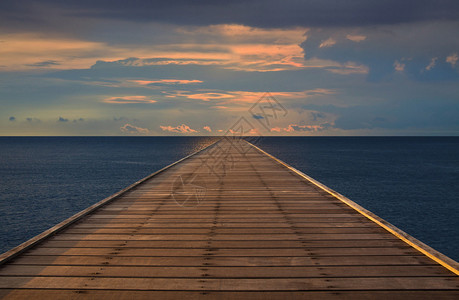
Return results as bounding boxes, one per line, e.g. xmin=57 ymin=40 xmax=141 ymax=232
xmin=0 ymin=0 xmax=459 ymax=136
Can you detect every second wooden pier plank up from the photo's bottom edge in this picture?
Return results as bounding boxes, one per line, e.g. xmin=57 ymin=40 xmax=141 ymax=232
xmin=0 ymin=276 xmax=459 ymax=291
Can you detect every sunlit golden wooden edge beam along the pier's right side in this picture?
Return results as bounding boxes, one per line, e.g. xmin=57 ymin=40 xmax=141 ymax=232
xmin=244 ymin=140 xmax=459 ymax=275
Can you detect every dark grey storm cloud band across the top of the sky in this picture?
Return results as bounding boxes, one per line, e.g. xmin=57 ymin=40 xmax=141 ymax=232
xmin=0 ymin=0 xmax=459 ymax=27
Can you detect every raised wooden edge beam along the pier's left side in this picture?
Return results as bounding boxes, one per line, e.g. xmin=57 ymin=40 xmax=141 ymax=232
xmin=0 ymin=139 xmax=221 ymax=266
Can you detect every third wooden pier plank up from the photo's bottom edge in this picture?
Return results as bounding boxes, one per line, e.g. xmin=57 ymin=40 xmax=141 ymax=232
xmin=2 ymin=265 xmax=454 ymax=278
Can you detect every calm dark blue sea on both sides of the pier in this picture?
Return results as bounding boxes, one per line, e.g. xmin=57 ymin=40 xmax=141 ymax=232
xmin=0 ymin=137 xmax=459 ymax=260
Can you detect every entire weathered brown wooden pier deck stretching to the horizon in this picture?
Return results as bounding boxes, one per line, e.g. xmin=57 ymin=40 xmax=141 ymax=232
xmin=0 ymin=140 xmax=459 ymax=299
